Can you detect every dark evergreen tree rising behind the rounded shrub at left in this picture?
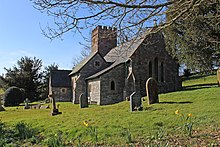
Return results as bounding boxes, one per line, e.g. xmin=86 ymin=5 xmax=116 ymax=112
xmin=4 ymin=57 xmax=42 ymax=101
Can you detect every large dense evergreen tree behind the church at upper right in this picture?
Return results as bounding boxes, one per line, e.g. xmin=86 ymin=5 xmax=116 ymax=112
xmin=165 ymin=0 xmax=220 ymax=71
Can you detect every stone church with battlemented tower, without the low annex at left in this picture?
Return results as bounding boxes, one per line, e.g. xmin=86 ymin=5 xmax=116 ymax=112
xmin=69 ymin=26 xmax=182 ymax=105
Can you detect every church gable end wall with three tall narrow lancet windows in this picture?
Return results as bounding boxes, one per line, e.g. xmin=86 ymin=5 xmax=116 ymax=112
xmin=131 ymin=33 xmax=181 ymax=96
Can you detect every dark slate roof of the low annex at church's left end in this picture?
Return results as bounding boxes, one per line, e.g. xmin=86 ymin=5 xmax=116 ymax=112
xmin=50 ymin=70 xmax=71 ymax=87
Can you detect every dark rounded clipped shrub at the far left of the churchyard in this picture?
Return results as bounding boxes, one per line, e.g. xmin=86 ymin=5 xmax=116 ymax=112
xmin=3 ymin=86 xmax=23 ymax=106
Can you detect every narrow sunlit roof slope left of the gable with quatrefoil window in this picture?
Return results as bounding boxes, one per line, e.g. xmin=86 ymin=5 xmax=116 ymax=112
xmin=69 ymin=52 xmax=98 ymax=75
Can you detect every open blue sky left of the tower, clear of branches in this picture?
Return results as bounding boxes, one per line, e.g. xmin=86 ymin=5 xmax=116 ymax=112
xmin=0 ymin=0 xmax=89 ymax=75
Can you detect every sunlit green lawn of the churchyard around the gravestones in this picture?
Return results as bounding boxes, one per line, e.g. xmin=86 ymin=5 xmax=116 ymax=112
xmin=0 ymin=76 xmax=220 ymax=145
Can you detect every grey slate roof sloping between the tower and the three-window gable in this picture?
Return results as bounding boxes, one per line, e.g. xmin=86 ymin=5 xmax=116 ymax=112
xmin=87 ymin=35 xmax=145 ymax=80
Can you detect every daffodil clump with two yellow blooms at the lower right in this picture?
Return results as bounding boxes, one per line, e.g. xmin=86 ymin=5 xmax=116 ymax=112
xmin=175 ymin=110 xmax=193 ymax=137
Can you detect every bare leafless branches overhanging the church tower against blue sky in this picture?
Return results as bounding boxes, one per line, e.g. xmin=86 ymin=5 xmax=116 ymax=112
xmin=32 ymin=0 xmax=205 ymax=40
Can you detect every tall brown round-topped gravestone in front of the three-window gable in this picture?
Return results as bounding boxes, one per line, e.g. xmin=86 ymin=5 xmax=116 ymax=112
xmin=146 ymin=77 xmax=159 ymax=104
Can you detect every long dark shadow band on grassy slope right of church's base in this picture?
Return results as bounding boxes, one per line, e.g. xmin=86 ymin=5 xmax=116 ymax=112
xmin=182 ymin=83 xmax=217 ymax=91
